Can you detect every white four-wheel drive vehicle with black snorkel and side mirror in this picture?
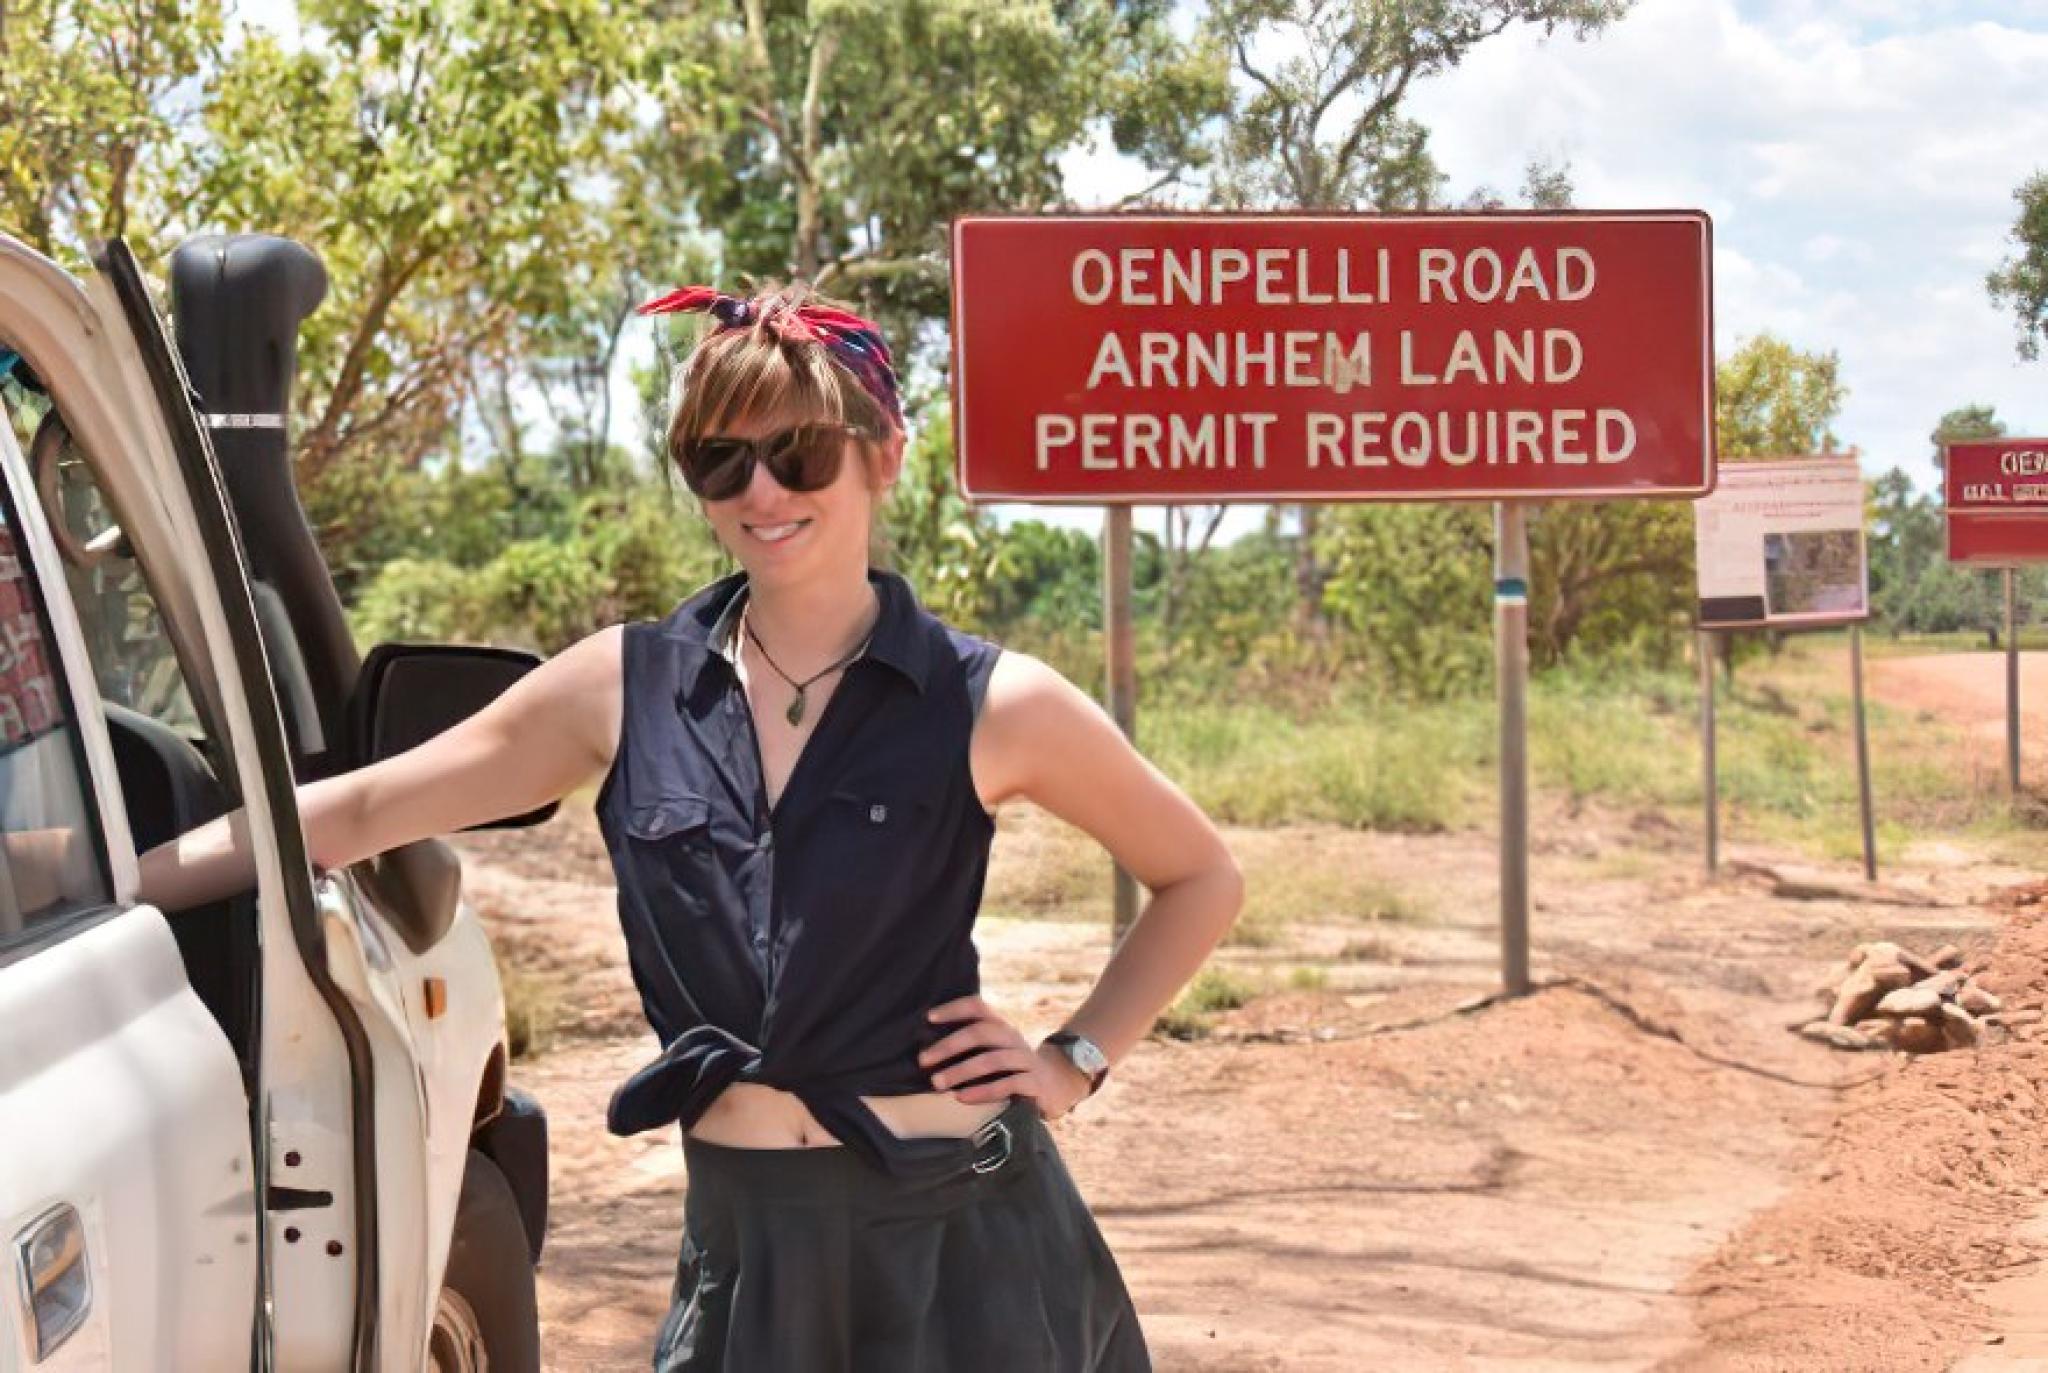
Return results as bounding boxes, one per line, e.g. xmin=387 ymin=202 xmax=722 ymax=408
xmin=0 ymin=236 xmax=551 ymax=1373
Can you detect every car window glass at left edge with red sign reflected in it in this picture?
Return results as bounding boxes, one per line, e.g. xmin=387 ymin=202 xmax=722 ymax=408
xmin=0 ymin=415 xmax=113 ymax=949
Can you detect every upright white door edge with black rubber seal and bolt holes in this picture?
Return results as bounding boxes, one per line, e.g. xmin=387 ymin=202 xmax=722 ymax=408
xmin=90 ymin=240 xmax=403 ymax=1373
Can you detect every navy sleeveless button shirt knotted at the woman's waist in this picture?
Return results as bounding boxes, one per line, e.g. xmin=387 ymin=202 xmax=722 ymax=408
xmin=596 ymin=572 xmax=1001 ymax=1176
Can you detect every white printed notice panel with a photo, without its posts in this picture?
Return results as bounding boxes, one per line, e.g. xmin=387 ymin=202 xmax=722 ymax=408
xmin=1692 ymin=457 xmax=1870 ymax=629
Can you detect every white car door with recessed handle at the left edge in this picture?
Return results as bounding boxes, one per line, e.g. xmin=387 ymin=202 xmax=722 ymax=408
xmin=0 ymin=319 xmax=260 ymax=1371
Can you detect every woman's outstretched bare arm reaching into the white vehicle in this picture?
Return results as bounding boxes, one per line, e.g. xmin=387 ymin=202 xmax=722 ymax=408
xmin=141 ymin=625 xmax=623 ymax=910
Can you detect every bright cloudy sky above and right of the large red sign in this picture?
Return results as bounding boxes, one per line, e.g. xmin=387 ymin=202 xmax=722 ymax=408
xmin=1036 ymin=0 xmax=2048 ymax=545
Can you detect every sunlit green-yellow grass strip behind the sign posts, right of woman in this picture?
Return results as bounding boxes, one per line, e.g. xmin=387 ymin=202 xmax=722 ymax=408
xmin=1141 ymin=633 xmax=2048 ymax=860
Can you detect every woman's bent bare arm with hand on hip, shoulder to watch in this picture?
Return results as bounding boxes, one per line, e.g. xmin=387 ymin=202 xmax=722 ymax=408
xmin=973 ymin=652 xmax=1243 ymax=1064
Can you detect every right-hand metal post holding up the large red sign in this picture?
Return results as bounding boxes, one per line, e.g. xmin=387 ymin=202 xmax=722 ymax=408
xmin=1493 ymin=500 xmax=1530 ymax=996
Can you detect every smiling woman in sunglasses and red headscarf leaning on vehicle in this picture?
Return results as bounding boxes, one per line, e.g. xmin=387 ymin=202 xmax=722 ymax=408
xmin=143 ymin=287 xmax=1241 ymax=1373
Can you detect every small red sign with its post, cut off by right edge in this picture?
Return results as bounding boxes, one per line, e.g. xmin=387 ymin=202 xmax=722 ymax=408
xmin=1942 ymin=439 xmax=2048 ymax=795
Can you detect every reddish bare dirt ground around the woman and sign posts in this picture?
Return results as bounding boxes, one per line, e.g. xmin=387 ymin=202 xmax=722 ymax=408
xmin=465 ymin=658 xmax=2048 ymax=1371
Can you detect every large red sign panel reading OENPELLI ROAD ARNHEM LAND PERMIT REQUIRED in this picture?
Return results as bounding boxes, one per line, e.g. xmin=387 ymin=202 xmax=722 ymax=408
xmin=952 ymin=211 xmax=1714 ymax=504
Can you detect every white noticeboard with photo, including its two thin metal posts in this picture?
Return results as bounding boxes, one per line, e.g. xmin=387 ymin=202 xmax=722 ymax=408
xmin=1692 ymin=455 xmax=1878 ymax=881
